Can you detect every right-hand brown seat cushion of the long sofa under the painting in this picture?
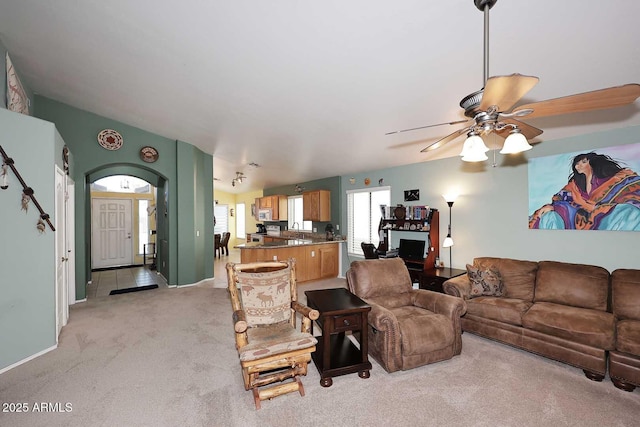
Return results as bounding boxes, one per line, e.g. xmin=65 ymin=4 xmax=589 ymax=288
xmin=522 ymin=302 xmax=615 ymax=350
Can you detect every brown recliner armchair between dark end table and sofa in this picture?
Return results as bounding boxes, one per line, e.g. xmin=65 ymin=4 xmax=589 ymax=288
xmin=347 ymin=258 xmax=467 ymax=372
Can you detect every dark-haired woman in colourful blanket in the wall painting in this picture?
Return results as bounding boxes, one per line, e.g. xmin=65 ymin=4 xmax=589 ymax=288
xmin=529 ymin=152 xmax=640 ymax=231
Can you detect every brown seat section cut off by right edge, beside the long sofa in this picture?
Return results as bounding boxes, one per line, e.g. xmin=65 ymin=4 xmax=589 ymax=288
xmin=609 ymin=269 xmax=640 ymax=391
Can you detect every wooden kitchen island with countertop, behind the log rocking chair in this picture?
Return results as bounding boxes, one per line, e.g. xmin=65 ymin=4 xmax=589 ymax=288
xmin=235 ymin=236 xmax=343 ymax=282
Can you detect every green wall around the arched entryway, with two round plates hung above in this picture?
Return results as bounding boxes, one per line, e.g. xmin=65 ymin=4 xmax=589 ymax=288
xmin=35 ymin=96 xmax=213 ymax=300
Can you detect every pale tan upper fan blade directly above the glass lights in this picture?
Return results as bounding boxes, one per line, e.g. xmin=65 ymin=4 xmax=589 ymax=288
xmin=480 ymin=74 xmax=540 ymax=111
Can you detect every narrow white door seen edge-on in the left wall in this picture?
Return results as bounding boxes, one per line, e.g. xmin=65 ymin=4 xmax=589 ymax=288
xmin=55 ymin=166 xmax=69 ymax=342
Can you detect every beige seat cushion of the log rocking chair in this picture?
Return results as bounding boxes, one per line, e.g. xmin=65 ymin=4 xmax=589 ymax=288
xmin=238 ymin=323 xmax=318 ymax=362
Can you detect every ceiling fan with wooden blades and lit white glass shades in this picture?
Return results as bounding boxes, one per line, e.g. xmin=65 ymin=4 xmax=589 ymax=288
xmin=386 ymin=0 xmax=640 ymax=162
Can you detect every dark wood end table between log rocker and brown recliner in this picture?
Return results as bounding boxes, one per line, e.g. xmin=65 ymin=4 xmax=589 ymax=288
xmin=305 ymin=288 xmax=371 ymax=387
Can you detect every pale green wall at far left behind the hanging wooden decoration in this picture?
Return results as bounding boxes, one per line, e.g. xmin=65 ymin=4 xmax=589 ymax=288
xmin=0 ymin=109 xmax=59 ymax=370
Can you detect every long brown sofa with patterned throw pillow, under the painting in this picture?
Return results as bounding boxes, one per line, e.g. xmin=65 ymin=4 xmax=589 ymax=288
xmin=444 ymin=257 xmax=616 ymax=381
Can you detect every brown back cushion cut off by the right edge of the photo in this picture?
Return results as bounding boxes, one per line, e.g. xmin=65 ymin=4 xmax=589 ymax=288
xmin=611 ymin=269 xmax=640 ymax=320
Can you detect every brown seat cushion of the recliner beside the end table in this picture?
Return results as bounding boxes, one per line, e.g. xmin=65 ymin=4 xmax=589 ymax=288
xmin=391 ymin=306 xmax=456 ymax=357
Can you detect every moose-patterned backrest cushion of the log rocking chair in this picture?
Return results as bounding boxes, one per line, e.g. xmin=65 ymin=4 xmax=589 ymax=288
xmin=238 ymin=268 xmax=291 ymax=327
